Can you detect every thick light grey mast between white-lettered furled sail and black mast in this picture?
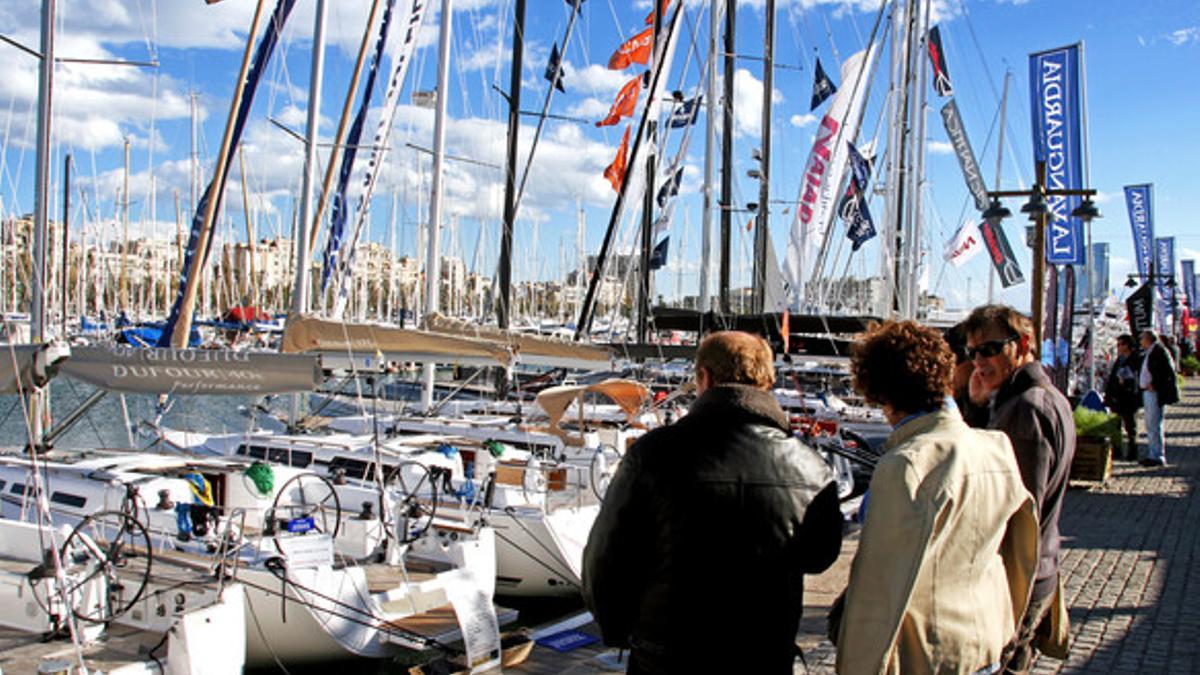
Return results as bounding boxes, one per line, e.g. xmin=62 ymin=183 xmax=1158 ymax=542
xmin=421 ymin=0 xmax=454 ymax=412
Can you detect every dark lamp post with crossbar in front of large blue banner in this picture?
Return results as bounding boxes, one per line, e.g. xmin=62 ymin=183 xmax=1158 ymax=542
xmin=983 ymin=162 xmax=1100 ymax=353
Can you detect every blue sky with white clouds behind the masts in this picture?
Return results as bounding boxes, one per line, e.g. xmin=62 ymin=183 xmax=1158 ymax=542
xmin=0 ymin=0 xmax=1200 ymax=309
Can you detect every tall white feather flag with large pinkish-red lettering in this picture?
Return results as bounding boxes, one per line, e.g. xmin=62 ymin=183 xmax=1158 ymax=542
xmin=784 ymin=49 xmax=875 ymax=305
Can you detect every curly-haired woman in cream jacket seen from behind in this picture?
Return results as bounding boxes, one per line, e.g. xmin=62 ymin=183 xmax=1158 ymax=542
xmin=838 ymin=321 xmax=1038 ymax=675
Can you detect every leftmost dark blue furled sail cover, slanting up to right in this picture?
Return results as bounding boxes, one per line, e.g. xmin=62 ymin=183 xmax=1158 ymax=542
xmin=158 ymin=0 xmax=295 ymax=347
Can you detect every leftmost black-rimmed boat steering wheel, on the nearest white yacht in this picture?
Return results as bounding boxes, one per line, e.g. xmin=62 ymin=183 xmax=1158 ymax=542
xmin=30 ymin=510 xmax=154 ymax=625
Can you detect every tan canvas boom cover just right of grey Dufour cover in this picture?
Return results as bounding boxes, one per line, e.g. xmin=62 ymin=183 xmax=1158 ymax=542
xmin=280 ymin=316 xmax=512 ymax=366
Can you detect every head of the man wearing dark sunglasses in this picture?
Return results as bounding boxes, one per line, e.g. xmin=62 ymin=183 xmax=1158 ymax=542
xmin=965 ymin=305 xmax=1034 ymax=393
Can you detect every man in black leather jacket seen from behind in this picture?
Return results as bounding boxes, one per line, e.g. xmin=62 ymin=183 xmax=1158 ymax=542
xmin=583 ymin=331 xmax=842 ymax=674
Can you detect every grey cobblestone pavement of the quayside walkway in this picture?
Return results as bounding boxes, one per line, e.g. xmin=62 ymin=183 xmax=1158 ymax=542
xmin=796 ymin=381 xmax=1200 ymax=675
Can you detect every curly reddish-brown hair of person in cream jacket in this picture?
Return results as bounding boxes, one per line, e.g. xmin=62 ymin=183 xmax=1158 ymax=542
xmin=850 ymin=321 xmax=954 ymax=413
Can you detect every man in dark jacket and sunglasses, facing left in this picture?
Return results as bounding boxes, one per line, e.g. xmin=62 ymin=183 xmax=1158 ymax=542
xmin=966 ymin=305 xmax=1075 ymax=673
